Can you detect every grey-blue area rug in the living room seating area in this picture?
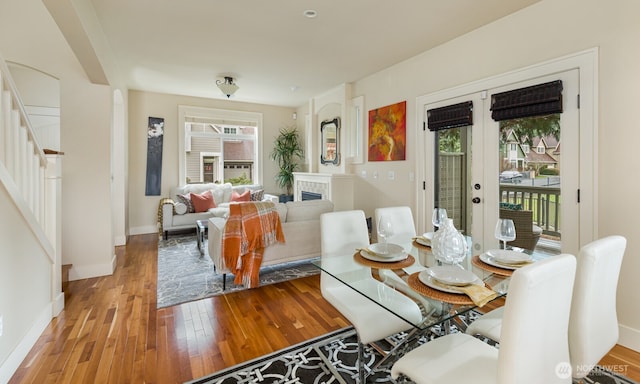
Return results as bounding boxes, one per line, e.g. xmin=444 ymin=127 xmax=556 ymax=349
xmin=157 ymin=234 xmax=320 ymax=308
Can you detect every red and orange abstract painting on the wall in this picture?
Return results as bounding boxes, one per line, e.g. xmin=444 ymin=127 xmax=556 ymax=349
xmin=369 ymin=101 xmax=407 ymax=161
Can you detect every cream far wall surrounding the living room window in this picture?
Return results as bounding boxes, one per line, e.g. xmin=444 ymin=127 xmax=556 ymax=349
xmin=128 ymin=91 xmax=303 ymax=234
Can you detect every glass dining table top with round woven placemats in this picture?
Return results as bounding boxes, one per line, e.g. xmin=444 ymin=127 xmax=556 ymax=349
xmin=313 ymin=240 xmax=544 ymax=354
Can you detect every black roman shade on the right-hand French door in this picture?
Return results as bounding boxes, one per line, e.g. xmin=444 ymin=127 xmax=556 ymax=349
xmin=491 ymin=80 xmax=562 ymax=121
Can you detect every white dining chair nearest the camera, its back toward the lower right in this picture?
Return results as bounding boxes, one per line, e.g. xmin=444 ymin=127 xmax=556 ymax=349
xmin=391 ymin=254 xmax=576 ymax=384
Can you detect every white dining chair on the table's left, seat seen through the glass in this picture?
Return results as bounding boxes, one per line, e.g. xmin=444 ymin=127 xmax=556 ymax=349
xmin=320 ymin=210 xmax=422 ymax=383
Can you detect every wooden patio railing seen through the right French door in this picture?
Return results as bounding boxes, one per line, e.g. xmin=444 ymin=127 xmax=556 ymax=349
xmin=500 ymin=184 xmax=561 ymax=237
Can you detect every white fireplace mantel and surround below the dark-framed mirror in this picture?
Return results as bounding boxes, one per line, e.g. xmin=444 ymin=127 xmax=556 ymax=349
xmin=293 ymin=172 xmax=353 ymax=211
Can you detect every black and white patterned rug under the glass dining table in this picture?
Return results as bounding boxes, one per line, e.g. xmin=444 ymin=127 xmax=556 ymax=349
xmin=188 ymin=312 xmax=638 ymax=384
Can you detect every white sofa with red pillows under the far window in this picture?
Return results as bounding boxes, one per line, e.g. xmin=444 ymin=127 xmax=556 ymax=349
xmin=158 ymin=183 xmax=278 ymax=239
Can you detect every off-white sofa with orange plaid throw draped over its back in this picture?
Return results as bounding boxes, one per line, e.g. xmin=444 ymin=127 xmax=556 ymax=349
xmin=208 ymin=200 xmax=333 ymax=286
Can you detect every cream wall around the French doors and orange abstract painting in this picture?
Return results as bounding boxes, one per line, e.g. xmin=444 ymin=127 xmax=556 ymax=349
xmin=353 ymin=0 xmax=640 ymax=350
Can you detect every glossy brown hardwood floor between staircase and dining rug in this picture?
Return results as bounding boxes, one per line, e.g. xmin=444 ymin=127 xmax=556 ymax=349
xmin=10 ymin=235 xmax=640 ymax=384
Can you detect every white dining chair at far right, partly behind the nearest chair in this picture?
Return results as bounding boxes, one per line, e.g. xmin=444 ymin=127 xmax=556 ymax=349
xmin=466 ymin=236 xmax=627 ymax=379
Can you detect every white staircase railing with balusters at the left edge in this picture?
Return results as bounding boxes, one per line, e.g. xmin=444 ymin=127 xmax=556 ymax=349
xmin=0 ymin=57 xmax=56 ymax=263
